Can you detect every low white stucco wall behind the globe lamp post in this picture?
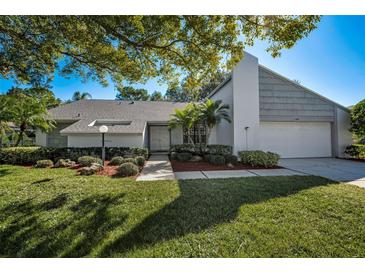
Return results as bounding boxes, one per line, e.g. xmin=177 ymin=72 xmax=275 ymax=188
xmin=67 ymin=134 xmax=144 ymax=147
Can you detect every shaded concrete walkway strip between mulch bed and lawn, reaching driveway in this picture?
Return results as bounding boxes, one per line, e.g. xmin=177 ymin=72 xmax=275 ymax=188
xmin=175 ymin=168 xmax=307 ymax=180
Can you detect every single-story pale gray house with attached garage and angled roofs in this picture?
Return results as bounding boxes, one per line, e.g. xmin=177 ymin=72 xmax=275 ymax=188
xmin=36 ymin=53 xmax=352 ymax=158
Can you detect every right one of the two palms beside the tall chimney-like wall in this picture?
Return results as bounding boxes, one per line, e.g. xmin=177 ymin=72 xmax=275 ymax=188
xmin=199 ymin=99 xmax=231 ymax=142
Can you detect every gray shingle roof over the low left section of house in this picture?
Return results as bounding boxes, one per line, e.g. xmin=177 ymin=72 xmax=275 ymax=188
xmin=49 ymin=100 xmax=187 ymax=134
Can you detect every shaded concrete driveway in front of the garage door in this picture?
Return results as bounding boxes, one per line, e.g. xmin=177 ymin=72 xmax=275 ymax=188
xmin=279 ymin=158 xmax=365 ymax=183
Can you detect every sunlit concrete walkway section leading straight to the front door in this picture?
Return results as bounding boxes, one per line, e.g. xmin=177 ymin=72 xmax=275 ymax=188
xmin=137 ymin=155 xmax=175 ymax=181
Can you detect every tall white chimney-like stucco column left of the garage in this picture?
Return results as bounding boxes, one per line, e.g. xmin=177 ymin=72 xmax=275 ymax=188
xmin=232 ymin=53 xmax=260 ymax=154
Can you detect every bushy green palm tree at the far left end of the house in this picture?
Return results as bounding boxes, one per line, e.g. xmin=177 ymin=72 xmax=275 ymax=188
xmin=11 ymin=94 xmax=55 ymax=146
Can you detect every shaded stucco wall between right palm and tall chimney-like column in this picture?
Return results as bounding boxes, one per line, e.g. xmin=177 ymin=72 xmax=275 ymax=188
xmin=208 ymin=80 xmax=233 ymax=146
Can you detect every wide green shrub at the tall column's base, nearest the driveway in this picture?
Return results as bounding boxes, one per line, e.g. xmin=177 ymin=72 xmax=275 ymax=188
xmin=238 ymin=150 xmax=280 ymax=167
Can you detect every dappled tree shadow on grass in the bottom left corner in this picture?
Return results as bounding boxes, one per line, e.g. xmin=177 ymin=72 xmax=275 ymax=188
xmin=0 ymin=193 xmax=126 ymax=257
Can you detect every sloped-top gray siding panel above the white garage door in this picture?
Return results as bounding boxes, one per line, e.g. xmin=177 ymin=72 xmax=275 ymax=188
xmin=259 ymin=66 xmax=335 ymax=121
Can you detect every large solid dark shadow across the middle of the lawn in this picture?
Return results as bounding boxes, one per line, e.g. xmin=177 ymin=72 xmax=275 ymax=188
xmin=99 ymin=176 xmax=334 ymax=257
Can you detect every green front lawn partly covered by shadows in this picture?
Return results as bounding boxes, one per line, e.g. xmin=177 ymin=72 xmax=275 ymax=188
xmin=0 ymin=165 xmax=365 ymax=257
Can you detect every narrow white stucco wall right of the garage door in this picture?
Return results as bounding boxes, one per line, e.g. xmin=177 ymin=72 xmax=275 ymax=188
xmin=335 ymin=108 xmax=352 ymax=157
